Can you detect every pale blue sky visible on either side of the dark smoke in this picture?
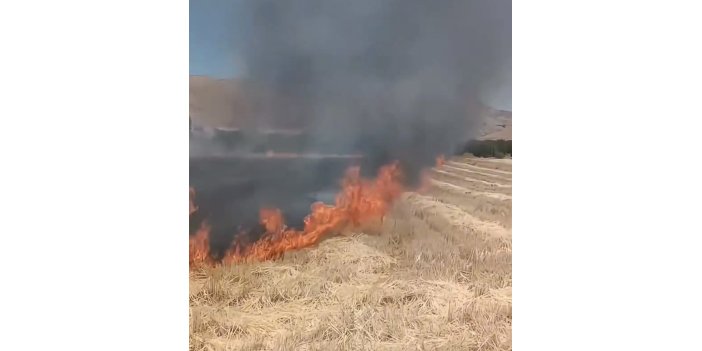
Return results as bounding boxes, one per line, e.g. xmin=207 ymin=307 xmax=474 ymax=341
xmin=189 ymin=0 xmax=512 ymax=111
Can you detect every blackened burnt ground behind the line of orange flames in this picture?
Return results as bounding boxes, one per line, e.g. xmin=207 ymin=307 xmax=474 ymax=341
xmin=190 ymin=129 xmax=363 ymax=257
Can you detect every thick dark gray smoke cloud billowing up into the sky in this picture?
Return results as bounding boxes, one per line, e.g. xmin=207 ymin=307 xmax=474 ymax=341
xmin=241 ymin=0 xmax=512 ymax=175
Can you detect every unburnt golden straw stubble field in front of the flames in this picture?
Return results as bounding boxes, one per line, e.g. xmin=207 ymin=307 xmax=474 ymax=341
xmin=190 ymin=156 xmax=512 ymax=351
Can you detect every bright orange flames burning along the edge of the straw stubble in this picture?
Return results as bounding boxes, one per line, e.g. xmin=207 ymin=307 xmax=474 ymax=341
xmin=190 ymin=162 xmax=404 ymax=264
